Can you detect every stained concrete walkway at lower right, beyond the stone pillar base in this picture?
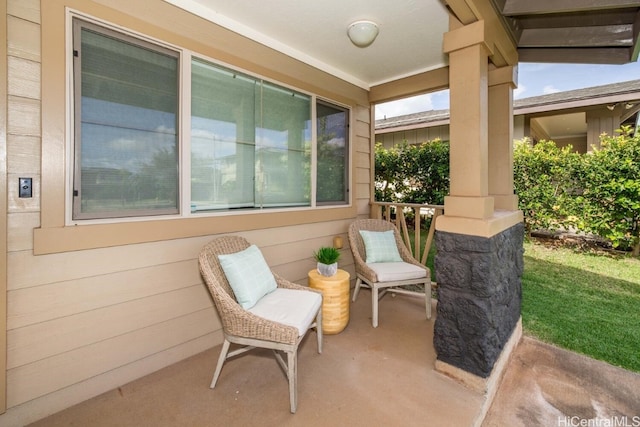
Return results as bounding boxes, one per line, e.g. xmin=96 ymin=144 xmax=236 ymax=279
xmin=483 ymin=337 xmax=640 ymax=427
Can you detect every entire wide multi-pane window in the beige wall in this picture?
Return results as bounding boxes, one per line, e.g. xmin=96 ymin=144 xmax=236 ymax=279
xmin=72 ymin=19 xmax=349 ymax=220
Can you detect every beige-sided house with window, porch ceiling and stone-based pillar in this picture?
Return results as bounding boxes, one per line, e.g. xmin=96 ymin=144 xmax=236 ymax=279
xmin=0 ymin=0 xmax=640 ymax=426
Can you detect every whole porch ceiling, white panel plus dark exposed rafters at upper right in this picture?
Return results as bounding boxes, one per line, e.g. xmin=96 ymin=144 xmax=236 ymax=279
xmin=165 ymin=0 xmax=640 ymax=89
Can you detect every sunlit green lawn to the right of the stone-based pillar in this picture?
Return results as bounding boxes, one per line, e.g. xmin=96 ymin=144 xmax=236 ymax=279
xmin=522 ymin=242 xmax=640 ymax=372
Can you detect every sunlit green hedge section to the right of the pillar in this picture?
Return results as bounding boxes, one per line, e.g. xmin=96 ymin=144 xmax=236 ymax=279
xmin=514 ymin=128 xmax=640 ymax=256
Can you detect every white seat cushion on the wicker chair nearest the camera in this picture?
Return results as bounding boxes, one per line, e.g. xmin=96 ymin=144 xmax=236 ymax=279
xmin=247 ymin=288 xmax=322 ymax=336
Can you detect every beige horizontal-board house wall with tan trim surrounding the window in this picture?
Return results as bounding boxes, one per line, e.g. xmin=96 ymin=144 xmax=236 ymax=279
xmin=0 ymin=0 xmax=372 ymax=425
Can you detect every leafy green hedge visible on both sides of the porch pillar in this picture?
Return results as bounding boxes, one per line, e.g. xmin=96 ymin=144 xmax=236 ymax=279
xmin=375 ymin=127 xmax=640 ymax=256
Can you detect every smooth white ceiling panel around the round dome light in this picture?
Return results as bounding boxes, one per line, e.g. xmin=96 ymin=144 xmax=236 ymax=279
xmin=165 ymin=0 xmax=449 ymax=89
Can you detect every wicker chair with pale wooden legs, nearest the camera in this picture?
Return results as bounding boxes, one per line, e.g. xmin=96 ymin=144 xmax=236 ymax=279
xmin=198 ymin=236 xmax=322 ymax=413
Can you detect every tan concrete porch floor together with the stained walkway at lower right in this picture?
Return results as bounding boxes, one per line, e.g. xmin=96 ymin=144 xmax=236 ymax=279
xmin=26 ymin=291 xmax=640 ymax=427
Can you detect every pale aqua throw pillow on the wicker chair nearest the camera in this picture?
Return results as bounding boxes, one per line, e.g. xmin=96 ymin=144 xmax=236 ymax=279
xmin=218 ymin=245 xmax=278 ymax=310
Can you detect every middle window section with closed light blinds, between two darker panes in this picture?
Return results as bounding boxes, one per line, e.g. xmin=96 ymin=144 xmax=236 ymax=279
xmin=191 ymin=59 xmax=311 ymax=211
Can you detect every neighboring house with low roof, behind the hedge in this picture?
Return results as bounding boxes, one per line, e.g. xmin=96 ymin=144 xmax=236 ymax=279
xmin=376 ymin=80 xmax=640 ymax=153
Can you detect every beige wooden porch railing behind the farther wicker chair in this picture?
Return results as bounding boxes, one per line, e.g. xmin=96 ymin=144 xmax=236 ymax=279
xmin=371 ymin=202 xmax=444 ymax=265
